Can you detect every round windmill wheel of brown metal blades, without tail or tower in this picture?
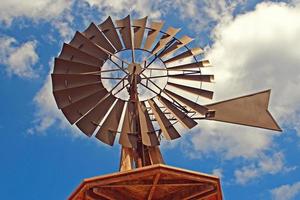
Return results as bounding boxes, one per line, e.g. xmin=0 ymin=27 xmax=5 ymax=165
xmin=52 ymin=16 xmax=214 ymax=148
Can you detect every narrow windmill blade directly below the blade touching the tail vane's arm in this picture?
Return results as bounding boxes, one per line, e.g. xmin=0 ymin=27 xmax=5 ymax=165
xmin=158 ymin=96 xmax=197 ymax=129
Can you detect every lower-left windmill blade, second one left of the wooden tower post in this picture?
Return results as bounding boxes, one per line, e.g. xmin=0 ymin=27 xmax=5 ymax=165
xmin=95 ymin=99 xmax=125 ymax=146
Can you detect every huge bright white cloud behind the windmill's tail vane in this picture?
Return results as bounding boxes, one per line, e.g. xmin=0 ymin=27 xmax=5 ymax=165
xmin=191 ymin=0 xmax=300 ymax=162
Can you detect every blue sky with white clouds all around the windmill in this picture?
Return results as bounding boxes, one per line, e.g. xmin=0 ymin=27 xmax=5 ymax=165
xmin=0 ymin=0 xmax=300 ymax=200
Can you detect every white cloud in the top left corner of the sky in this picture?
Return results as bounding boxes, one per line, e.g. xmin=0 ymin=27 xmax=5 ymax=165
xmin=0 ymin=0 xmax=72 ymax=25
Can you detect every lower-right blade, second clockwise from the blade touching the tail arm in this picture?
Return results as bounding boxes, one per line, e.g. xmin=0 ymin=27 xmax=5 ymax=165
xmin=148 ymin=99 xmax=180 ymax=140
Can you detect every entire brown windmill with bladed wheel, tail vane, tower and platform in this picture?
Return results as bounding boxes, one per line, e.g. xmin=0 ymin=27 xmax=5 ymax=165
xmin=51 ymin=15 xmax=281 ymax=200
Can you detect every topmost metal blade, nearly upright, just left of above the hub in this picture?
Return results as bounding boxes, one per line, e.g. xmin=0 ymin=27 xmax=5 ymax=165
xmin=115 ymin=15 xmax=132 ymax=49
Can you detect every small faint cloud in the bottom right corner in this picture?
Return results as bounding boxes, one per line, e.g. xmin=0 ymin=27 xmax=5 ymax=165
xmin=271 ymin=182 xmax=300 ymax=200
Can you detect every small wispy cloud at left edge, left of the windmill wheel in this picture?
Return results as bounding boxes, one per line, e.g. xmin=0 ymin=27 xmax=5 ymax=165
xmin=0 ymin=36 xmax=39 ymax=78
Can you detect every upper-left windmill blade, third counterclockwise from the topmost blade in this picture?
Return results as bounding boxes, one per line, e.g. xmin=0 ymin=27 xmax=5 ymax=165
xmin=70 ymin=31 xmax=108 ymax=60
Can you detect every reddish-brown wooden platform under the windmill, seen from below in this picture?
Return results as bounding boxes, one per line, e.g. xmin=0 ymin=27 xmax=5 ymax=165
xmin=69 ymin=164 xmax=222 ymax=200
